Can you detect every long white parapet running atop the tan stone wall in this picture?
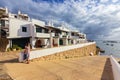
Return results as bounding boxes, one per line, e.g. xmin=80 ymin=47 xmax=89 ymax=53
xmin=30 ymin=42 xmax=95 ymax=59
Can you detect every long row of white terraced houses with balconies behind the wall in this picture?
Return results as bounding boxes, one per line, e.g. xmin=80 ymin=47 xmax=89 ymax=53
xmin=0 ymin=8 xmax=87 ymax=49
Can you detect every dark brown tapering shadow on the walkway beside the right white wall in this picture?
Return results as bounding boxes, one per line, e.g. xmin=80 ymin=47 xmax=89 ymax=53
xmin=101 ymin=58 xmax=114 ymax=80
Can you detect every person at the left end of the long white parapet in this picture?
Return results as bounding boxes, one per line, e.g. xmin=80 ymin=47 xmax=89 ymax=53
xmin=23 ymin=43 xmax=30 ymax=64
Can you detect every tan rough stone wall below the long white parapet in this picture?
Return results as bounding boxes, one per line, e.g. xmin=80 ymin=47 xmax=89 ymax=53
xmin=31 ymin=44 xmax=96 ymax=61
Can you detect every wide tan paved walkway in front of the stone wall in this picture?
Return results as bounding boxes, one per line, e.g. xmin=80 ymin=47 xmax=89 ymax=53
xmin=1 ymin=56 xmax=114 ymax=80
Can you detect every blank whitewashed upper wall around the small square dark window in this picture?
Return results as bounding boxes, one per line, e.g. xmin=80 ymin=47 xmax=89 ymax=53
xmin=8 ymin=18 xmax=32 ymax=38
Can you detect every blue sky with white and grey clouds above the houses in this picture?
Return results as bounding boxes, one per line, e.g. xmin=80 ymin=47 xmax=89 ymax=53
xmin=0 ymin=0 xmax=120 ymax=40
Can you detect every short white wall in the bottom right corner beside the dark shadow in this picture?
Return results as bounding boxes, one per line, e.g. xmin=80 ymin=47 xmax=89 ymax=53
xmin=110 ymin=56 xmax=120 ymax=80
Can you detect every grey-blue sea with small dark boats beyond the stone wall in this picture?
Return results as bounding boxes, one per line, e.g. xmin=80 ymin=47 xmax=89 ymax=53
xmin=95 ymin=40 xmax=120 ymax=58
